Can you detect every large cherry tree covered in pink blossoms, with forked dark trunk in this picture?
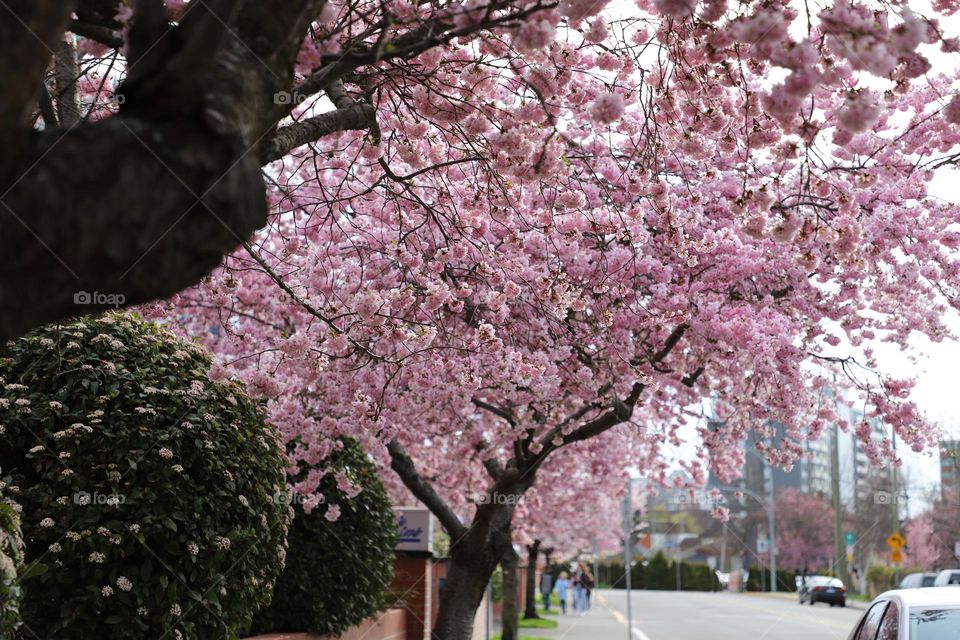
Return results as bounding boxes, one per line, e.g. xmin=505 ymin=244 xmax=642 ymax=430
xmin=104 ymin=0 xmax=960 ymax=639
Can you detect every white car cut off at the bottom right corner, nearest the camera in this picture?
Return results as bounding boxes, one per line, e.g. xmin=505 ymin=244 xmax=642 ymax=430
xmin=848 ymin=587 xmax=960 ymax=640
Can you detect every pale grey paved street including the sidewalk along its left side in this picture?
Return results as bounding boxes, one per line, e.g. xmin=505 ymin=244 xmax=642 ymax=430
xmin=521 ymin=590 xmax=862 ymax=640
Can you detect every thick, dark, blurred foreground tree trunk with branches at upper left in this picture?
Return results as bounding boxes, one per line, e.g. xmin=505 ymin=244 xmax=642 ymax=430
xmin=0 ymin=0 xmax=550 ymax=341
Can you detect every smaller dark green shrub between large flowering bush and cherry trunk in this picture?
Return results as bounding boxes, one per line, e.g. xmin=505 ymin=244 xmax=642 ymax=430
xmin=254 ymin=438 xmax=397 ymax=636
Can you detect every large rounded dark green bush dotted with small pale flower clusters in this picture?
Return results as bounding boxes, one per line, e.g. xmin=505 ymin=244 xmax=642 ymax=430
xmin=0 ymin=313 xmax=292 ymax=640
